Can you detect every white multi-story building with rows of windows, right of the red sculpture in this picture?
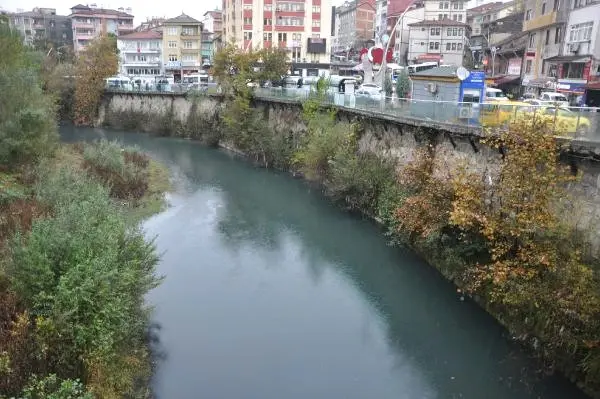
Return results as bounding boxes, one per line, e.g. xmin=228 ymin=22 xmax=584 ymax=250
xmin=408 ymin=0 xmax=470 ymax=65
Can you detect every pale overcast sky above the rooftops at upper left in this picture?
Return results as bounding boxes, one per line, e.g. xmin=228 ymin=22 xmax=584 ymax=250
xmin=0 ymin=0 xmax=344 ymax=24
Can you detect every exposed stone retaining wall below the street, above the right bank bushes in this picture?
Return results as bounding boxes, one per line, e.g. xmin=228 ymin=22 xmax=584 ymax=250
xmin=97 ymin=93 xmax=600 ymax=252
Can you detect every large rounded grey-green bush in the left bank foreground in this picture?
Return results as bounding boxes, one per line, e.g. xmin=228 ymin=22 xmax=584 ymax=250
xmin=7 ymin=169 xmax=159 ymax=395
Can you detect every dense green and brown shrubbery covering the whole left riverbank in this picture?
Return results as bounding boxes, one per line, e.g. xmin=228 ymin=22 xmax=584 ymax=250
xmin=0 ymin=24 xmax=168 ymax=399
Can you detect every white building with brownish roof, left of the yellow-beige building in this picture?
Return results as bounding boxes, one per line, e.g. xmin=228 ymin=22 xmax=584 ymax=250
xmin=117 ymin=30 xmax=164 ymax=78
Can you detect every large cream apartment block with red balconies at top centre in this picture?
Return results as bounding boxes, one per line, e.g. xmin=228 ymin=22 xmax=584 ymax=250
xmin=223 ymin=0 xmax=332 ymax=69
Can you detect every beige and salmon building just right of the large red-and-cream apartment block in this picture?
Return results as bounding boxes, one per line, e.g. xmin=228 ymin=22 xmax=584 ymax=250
xmin=335 ymin=0 xmax=376 ymax=50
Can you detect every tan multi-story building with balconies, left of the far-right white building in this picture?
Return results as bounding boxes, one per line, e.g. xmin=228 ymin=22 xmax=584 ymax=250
xmin=521 ymin=0 xmax=568 ymax=93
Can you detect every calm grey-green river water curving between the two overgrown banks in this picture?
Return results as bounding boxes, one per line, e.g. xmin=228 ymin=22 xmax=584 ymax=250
xmin=62 ymin=127 xmax=584 ymax=399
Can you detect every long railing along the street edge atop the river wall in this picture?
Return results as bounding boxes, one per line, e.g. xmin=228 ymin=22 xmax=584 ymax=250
xmin=107 ymin=84 xmax=600 ymax=141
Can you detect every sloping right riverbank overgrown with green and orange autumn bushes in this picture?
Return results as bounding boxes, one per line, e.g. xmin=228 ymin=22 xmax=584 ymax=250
xmin=98 ymin=92 xmax=600 ymax=397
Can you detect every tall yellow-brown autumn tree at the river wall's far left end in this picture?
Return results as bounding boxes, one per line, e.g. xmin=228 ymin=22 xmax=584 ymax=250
xmin=74 ymin=36 xmax=118 ymax=124
